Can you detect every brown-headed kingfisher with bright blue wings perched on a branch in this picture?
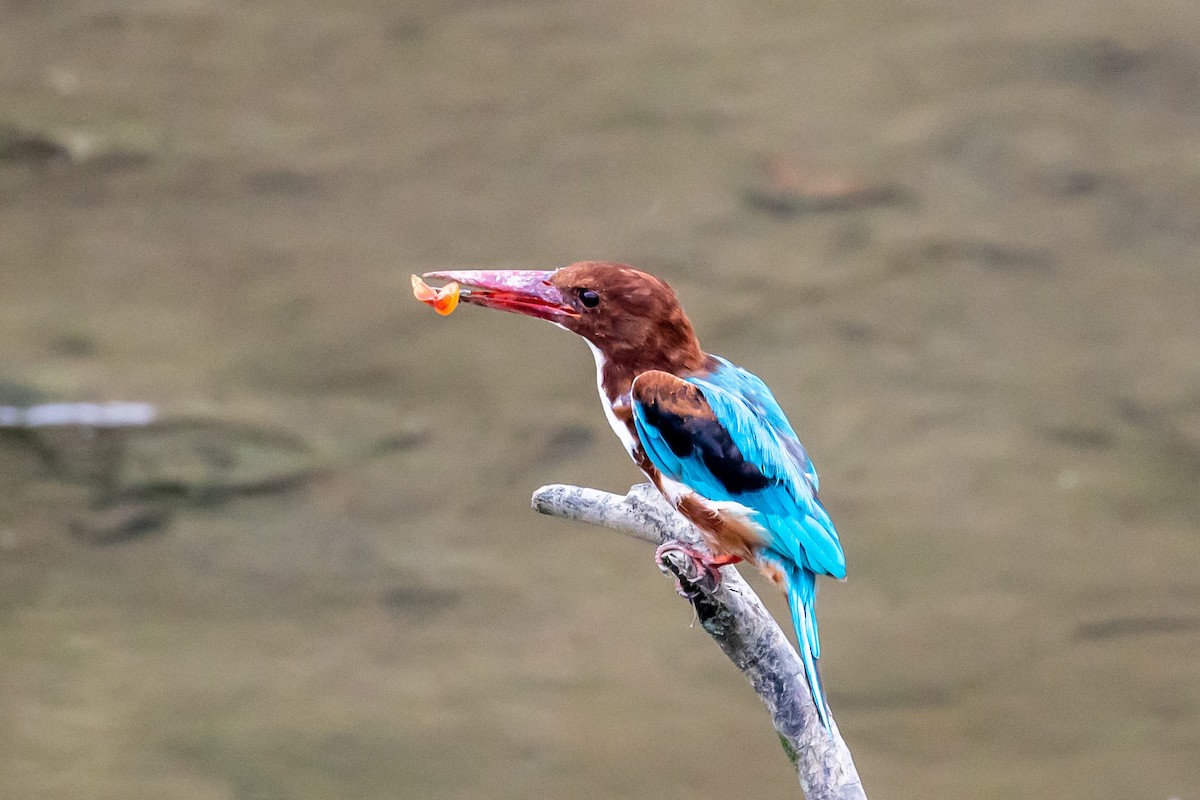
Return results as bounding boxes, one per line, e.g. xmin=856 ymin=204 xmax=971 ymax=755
xmin=414 ymin=261 xmax=846 ymax=729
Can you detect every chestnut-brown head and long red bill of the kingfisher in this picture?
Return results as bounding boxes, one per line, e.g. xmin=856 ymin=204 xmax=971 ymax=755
xmin=425 ymin=261 xmax=700 ymax=361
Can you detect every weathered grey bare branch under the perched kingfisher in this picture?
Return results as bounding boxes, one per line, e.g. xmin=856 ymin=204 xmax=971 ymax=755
xmin=533 ymin=483 xmax=866 ymax=800
